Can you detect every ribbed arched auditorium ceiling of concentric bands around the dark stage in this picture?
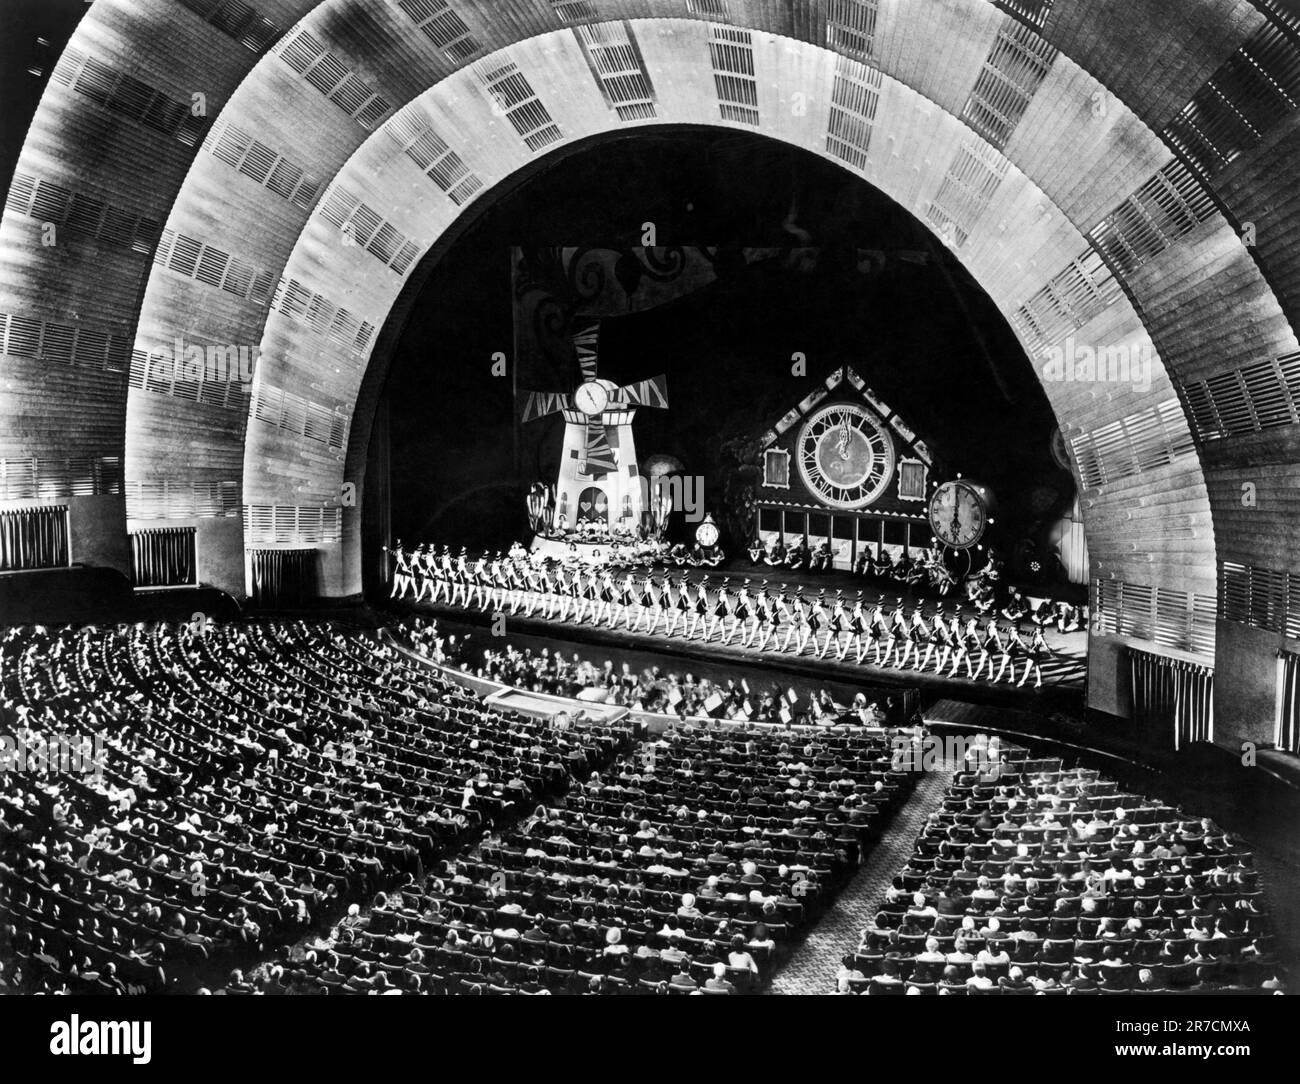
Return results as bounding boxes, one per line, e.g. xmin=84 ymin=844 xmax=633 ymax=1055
xmin=0 ymin=0 xmax=1300 ymax=655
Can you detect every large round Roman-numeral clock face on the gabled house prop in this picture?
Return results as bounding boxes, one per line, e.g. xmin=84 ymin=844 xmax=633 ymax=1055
xmin=798 ymin=403 xmax=894 ymax=508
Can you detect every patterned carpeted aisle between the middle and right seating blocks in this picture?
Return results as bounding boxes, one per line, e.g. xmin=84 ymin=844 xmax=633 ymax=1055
xmin=771 ymin=771 xmax=953 ymax=994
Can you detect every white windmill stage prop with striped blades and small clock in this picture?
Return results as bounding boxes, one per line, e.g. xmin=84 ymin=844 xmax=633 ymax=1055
xmin=523 ymin=317 xmax=668 ymax=548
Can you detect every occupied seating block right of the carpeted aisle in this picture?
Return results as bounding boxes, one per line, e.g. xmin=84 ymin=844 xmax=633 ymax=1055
xmin=839 ymin=749 xmax=1286 ymax=996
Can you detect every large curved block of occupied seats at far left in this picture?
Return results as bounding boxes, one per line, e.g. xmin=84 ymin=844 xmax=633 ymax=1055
xmin=0 ymin=623 xmax=629 ymax=993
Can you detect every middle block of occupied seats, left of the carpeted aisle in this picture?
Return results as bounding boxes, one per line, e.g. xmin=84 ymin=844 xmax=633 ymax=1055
xmin=263 ymin=727 xmax=914 ymax=994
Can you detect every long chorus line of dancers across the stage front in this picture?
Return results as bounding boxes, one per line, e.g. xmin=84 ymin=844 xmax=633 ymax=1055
xmin=391 ymin=541 xmax=1056 ymax=688
